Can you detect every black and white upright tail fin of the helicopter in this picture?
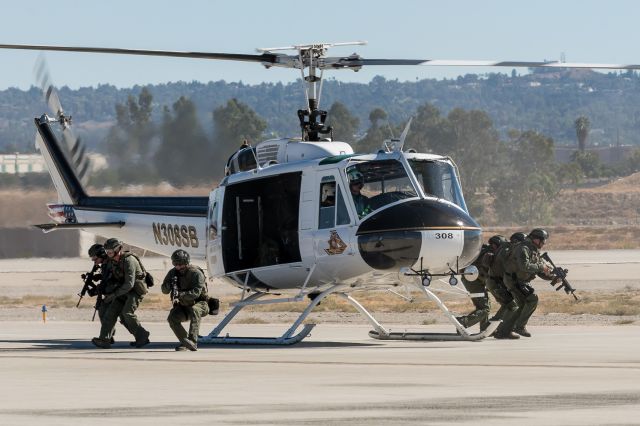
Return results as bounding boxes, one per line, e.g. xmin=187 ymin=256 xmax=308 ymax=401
xmin=35 ymin=114 xmax=87 ymax=205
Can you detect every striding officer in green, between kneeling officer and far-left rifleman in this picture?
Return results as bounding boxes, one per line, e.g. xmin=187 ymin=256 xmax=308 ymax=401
xmin=91 ymin=238 xmax=149 ymax=349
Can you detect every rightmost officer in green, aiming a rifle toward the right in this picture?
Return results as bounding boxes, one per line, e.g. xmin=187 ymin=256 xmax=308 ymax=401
xmin=503 ymin=228 xmax=551 ymax=337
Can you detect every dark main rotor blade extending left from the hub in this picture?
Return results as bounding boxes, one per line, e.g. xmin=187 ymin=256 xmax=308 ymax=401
xmin=0 ymin=44 xmax=277 ymax=63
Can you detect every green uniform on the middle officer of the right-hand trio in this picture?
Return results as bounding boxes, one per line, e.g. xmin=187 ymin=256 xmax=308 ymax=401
xmin=487 ymin=242 xmax=518 ymax=334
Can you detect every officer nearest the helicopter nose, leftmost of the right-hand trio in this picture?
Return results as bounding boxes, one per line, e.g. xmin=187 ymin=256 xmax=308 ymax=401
xmin=456 ymin=235 xmax=507 ymax=331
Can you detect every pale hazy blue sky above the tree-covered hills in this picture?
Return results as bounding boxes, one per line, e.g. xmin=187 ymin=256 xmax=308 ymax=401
xmin=0 ymin=0 xmax=640 ymax=89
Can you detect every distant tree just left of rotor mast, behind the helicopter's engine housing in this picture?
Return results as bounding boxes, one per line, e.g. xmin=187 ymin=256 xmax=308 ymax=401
xmin=213 ymin=98 xmax=267 ymax=175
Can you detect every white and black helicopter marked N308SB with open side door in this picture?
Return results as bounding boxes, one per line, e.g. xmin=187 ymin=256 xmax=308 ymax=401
xmin=0 ymin=41 xmax=640 ymax=344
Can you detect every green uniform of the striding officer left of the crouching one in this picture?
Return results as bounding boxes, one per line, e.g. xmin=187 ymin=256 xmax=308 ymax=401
xmin=100 ymin=252 xmax=149 ymax=344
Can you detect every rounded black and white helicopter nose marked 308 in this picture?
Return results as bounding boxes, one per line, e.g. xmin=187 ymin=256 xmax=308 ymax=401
xmin=356 ymin=199 xmax=482 ymax=273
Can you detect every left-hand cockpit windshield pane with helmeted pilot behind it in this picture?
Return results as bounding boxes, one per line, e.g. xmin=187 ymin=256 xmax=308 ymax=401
xmin=346 ymin=160 xmax=418 ymax=217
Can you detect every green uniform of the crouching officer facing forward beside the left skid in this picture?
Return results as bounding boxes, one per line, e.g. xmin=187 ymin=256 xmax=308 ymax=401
xmin=162 ymin=265 xmax=209 ymax=343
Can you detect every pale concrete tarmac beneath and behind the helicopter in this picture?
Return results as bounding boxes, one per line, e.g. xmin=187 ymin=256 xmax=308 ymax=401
xmin=0 ymin=250 xmax=640 ymax=426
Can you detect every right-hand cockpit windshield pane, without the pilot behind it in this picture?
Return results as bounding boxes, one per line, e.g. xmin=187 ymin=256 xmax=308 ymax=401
xmin=408 ymin=158 xmax=468 ymax=211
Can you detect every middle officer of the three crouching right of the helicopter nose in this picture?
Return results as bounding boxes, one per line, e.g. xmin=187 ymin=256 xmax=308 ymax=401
xmin=487 ymin=232 xmax=527 ymax=339
